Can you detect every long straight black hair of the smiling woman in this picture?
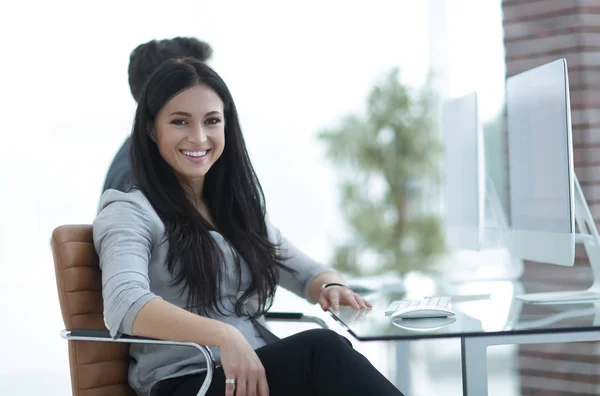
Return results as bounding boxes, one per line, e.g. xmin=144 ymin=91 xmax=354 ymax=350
xmin=130 ymin=58 xmax=290 ymax=317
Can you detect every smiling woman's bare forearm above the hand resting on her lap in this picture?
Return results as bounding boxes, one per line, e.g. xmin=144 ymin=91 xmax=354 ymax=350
xmin=133 ymin=299 xmax=234 ymax=346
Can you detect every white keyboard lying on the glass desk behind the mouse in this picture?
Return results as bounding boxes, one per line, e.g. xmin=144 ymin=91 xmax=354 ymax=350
xmin=385 ymin=296 xmax=455 ymax=319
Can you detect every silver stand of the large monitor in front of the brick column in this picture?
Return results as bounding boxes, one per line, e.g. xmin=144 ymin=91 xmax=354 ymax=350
xmin=516 ymin=175 xmax=600 ymax=304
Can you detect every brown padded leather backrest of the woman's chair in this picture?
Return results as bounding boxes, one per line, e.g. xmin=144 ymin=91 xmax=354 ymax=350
xmin=52 ymin=225 xmax=135 ymax=396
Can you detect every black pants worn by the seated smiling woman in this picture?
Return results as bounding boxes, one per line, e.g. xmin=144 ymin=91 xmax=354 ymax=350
xmin=156 ymin=329 xmax=402 ymax=396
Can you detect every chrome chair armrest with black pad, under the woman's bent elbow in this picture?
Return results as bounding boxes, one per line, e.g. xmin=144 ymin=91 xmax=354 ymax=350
xmin=60 ymin=329 xmax=215 ymax=396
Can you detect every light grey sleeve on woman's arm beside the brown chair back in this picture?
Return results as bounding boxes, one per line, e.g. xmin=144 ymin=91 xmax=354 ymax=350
xmin=93 ymin=190 xmax=159 ymax=337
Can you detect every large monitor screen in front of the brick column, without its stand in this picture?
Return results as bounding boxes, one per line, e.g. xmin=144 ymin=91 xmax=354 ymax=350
xmin=506 ymin=59 xmax=575 ymax=266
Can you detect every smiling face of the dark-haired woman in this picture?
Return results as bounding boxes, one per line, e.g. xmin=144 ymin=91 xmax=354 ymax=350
xmin=154 ymin=85 xmax=225 ymax=187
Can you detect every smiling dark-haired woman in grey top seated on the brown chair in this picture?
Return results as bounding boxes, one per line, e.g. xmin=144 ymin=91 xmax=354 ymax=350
xmin=93 ymin=59 xmax=401 ymax=396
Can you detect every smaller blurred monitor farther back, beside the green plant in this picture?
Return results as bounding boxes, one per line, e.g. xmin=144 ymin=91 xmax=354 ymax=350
xmin=442 ymin=92 xmax=485 ymax=250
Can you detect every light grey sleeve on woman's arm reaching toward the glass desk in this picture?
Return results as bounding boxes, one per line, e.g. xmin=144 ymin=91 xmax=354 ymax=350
xmin=266 ymin=219 xmax=335 ymax=303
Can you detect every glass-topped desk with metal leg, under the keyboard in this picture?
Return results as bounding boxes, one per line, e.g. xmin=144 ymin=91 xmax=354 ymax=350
xmin=329 ymin=283 xmax=600 ymax=396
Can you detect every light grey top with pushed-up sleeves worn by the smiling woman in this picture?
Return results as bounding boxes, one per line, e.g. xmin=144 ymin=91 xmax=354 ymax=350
xmin=94 ymin=190 xmax=332 ymax=395
